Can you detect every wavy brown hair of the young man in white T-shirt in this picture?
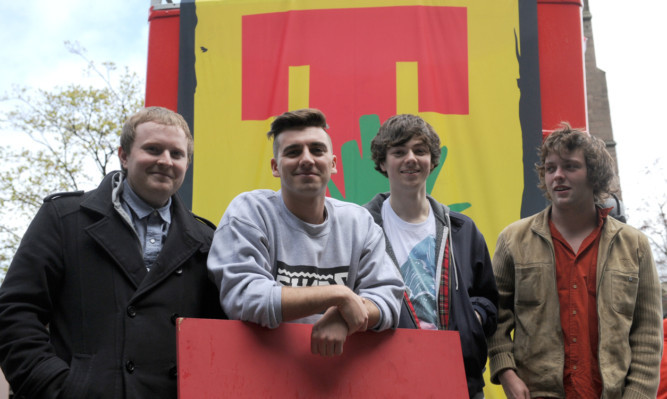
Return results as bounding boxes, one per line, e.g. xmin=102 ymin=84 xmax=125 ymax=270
xmin=371 ymin=114 xmax=441 ymax=176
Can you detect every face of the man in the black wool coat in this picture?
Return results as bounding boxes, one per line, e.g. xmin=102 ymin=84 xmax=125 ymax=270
xmin=118 ymin=122 xmax=188 ymax=208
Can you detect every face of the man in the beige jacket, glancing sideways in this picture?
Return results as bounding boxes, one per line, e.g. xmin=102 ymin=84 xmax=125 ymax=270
xmin=544 ymin=148 xmax=595 ymax=210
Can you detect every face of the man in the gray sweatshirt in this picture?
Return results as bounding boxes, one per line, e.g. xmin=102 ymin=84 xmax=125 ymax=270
xmin=271 ymin=127 xmax=336 ymax=202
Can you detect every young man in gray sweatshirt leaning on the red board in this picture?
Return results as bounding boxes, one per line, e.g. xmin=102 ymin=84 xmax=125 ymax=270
xmin=208 ymin=109 xmax=404 ymax=356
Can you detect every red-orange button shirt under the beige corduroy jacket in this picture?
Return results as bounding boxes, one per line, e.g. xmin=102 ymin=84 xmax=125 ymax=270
xmin=549 ymin=208 xmax=611 ymax=399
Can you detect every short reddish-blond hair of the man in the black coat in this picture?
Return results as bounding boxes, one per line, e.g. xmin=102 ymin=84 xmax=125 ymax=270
xmin=120 ymin=107 xmax=194 ymax=162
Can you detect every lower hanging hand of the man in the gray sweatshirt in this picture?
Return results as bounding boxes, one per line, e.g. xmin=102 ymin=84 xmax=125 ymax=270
xmin=310 ymin=306 xmax=348 ymax=356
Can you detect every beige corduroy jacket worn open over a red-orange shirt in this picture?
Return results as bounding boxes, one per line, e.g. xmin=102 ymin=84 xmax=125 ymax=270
xmin=488 ymin=207 xmax=662 ymax=399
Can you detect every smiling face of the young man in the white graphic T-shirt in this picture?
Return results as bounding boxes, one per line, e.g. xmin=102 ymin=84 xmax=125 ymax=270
xmin=380 ymin=137 xmax=433 ymax=191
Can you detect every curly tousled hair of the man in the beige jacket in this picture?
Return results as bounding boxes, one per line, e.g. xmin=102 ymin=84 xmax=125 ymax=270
xmin=535 ymin=122 xmax=616 ymax=204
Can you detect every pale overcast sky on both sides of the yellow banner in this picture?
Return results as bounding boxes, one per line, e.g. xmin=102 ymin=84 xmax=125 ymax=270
xmin=0 ymin=0 xmax=667 ymax=244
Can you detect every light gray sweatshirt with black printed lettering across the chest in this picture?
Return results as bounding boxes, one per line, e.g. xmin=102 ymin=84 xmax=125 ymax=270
xmin=208 ymin=190 xmax=404 ymax=331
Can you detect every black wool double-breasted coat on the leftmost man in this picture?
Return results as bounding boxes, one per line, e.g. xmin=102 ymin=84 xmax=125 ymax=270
xmin=0 ymin=173 xmax=223 ymax=398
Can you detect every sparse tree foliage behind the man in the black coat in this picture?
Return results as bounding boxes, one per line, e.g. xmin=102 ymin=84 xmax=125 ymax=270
xmin=0 ymin=43 xmax=143 ymax=281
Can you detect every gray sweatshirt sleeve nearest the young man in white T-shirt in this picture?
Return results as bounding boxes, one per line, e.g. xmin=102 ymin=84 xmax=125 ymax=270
xmin=354 ymin=220 xmax=405 ymax=331
